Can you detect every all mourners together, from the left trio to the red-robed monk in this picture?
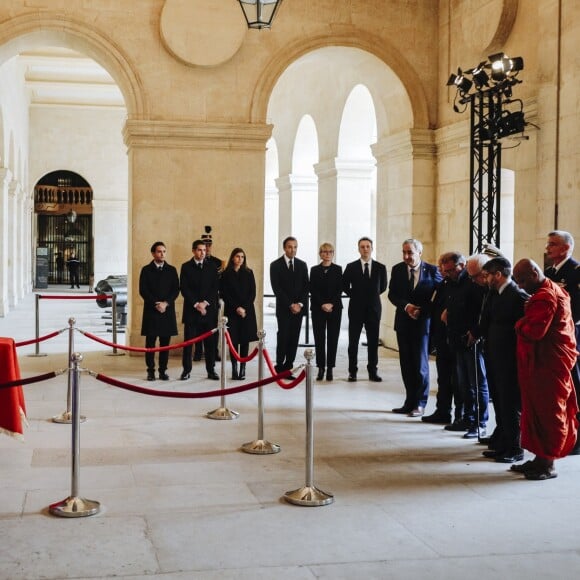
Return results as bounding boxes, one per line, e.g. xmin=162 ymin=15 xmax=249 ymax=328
xmin=139 ymin=230 xmax=580 ymax=480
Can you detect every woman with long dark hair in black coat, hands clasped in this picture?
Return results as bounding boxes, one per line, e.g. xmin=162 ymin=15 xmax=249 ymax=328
xmin=220 ymin=248 xmax=258 ymax=380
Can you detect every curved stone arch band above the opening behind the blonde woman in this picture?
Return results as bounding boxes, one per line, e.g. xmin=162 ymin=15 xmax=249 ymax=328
xmin=250 ymin=28 xmax=435 ymax=129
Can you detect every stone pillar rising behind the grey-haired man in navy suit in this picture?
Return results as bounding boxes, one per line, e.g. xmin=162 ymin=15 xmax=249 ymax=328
xmin=372 ymin=129 xmax=436 ymax=346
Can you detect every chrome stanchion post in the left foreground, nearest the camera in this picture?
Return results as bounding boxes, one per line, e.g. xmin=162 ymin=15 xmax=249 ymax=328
xmin=48 ymin=352 xmax=101 ymax=518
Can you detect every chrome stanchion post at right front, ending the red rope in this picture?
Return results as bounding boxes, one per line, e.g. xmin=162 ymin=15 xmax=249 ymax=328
xmin=284 ymin=349 xmax=334 ymax=506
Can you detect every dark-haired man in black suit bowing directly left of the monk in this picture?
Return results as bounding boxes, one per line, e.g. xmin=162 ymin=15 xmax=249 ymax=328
xmin=481 ymin=257 xmax=529 ymax=463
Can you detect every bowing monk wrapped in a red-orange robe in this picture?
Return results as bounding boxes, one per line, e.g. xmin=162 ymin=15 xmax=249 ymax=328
xmin=511 ymin=259 xmax=578 ymax=480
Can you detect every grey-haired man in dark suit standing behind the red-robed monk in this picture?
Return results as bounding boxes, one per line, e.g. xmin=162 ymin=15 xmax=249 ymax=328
xmin=545 ymin=230 xmax=580 ymax=455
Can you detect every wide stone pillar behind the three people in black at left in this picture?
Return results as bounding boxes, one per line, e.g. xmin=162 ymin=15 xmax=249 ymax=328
xmin=123 ymin=115 xmax=272 ymax=345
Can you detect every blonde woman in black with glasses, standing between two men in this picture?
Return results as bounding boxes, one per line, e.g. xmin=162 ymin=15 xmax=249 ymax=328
xmin=310 ymin=243 xmax=342 ymax=381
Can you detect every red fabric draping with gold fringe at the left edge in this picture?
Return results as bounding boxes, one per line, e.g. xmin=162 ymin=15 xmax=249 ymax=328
xmin=0 ymin=337 xmax=26 ymax=437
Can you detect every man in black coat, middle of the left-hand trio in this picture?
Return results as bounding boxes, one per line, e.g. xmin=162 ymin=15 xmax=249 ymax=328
xmin=179 ymin=240 xmax=219 ymax=381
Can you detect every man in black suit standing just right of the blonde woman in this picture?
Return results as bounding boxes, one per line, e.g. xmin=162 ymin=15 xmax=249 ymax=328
xmin=342 ymin=237 xmax=387 ymax=382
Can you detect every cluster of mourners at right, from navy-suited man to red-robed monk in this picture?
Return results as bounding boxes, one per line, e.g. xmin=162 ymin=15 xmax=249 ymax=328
xmin=389 ymin=230 xmax=580 ymax=480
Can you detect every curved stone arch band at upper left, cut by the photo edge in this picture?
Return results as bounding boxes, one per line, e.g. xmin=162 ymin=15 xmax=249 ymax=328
xmin=0 ymin=12 xmax=149 ymax=119
